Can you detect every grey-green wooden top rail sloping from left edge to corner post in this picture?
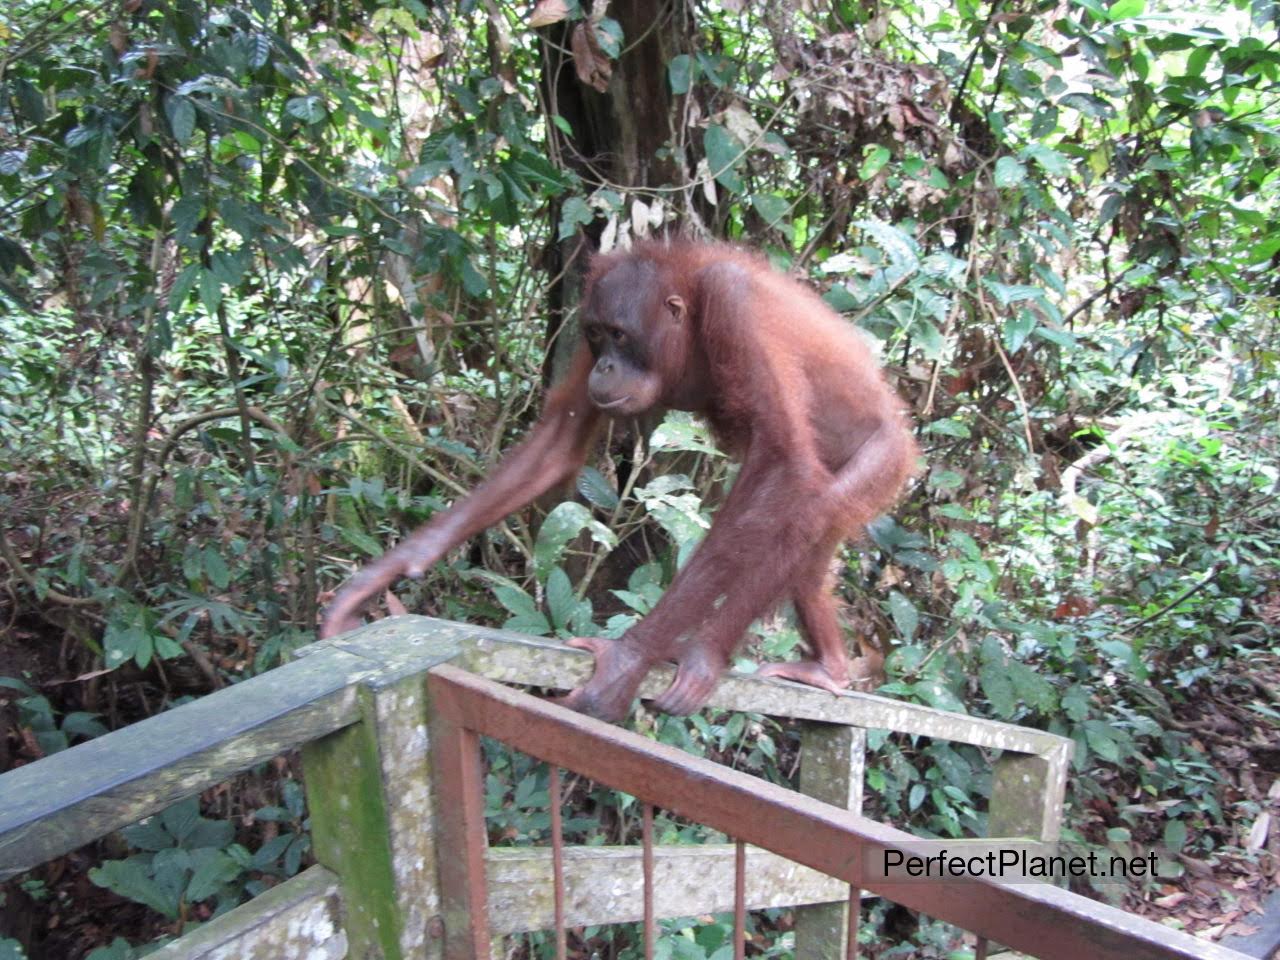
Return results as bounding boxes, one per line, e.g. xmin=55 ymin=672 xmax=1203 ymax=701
xmin=0 ymin=617 xmax=456 ymax=881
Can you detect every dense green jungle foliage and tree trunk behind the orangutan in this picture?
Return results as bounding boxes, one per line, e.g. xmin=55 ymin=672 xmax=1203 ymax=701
xmin=0 ymin=0 xmax=1280 ymax=960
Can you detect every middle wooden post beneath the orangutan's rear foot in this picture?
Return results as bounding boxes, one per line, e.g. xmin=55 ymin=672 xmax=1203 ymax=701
xmin=796 ymin=723 xmax=867 ymax=960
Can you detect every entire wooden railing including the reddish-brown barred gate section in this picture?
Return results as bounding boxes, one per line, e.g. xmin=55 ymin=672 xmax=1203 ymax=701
xmin=0 ymin=617 xmax=1242 ymax=960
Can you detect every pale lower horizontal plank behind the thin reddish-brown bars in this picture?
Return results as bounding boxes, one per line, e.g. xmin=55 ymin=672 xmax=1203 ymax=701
xmin=485 ymin=844 xmax=849 ymax=933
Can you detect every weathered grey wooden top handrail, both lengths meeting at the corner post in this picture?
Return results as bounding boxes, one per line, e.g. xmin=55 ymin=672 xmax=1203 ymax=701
xmin=0 ymin=616 xmax=1071 ymax=881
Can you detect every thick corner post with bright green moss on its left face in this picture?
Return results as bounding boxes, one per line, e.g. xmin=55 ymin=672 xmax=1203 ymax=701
xmin=302 ymin=620 xmax=457 ymax=960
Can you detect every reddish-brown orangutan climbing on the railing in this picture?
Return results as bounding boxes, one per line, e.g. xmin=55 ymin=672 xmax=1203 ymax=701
xmin=321 ymin=241 xmax=916 ymax=719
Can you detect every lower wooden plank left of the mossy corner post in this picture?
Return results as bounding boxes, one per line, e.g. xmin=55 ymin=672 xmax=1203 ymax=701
xmin=150 ymin=867 xmax=347 ymax=960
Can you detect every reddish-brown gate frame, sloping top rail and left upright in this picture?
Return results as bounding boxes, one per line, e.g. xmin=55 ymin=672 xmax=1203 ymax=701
xmin=428 ymin=664 xmax=1243 ymax=960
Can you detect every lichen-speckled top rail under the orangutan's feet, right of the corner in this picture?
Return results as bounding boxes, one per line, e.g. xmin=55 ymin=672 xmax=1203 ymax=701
xmin=440 ymin=617 xmax=1066 ymax=755
